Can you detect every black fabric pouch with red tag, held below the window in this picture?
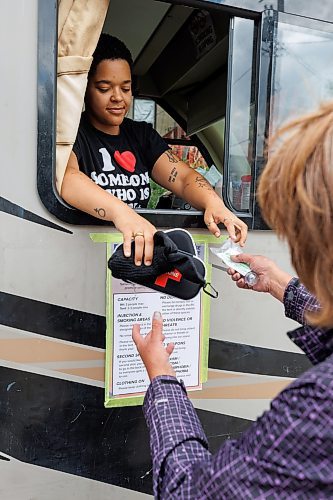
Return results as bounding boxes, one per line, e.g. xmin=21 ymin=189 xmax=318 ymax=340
xmin=108 ymin=229 xmax=217 ymax=300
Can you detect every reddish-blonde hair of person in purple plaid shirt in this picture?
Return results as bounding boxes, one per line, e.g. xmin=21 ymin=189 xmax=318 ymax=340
xmin=258 ymin=102 xmax=333 ymax=327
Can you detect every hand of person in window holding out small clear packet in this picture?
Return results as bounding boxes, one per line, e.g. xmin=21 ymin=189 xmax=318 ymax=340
xmin=204 ymin=200 xmax=247 ymax=247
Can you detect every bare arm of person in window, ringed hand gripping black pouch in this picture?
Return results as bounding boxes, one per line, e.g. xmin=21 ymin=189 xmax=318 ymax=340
xmin=61 ymin=153 xmax=156 ymax=265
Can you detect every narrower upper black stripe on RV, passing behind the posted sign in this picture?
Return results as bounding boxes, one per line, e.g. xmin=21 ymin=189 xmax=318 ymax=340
xmin=0 ymin=292 xmax=311 ymax=378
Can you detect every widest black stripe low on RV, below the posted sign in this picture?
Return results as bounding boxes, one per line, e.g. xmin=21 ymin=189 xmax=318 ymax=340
xmin=0 ymin=367 xmax=251 ymax=494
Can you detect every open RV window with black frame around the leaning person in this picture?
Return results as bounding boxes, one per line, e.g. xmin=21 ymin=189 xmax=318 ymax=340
xmin=38 ymin=0 xmax=260 ymax=227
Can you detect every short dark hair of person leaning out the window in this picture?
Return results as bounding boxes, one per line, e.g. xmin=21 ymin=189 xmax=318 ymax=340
xmin=88 ymin=33 xmax=133 ymax=78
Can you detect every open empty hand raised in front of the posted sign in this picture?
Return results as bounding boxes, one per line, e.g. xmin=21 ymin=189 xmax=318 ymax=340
xmin=132 ymin=311 xmax=176 ymax=380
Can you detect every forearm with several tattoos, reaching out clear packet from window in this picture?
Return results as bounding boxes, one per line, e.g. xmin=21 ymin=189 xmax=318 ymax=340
xmin=152 ymin=150 xmax=247 ymax=246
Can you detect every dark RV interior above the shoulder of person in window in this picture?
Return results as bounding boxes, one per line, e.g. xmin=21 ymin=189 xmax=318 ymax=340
xmin=104 ymin=0 xmax=230 ymax=134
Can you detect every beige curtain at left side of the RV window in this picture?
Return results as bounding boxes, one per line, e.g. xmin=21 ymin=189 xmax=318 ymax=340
xmin=56 ymin=0 xmax=109 ymax=193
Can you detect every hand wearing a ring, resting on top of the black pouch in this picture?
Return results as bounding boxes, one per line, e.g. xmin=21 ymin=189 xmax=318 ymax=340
xmin=113 ymin=205 xmax=156 ymax=266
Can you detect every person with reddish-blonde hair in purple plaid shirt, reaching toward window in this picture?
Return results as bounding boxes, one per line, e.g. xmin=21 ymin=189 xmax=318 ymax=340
xmin=133 ymin=103 xmax=333 ymax=500
